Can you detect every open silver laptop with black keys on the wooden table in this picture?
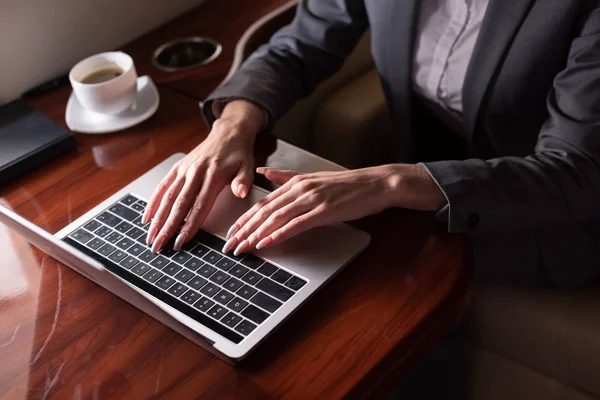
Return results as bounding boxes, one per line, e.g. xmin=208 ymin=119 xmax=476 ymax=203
xmin=0 ymin=153 xmax=370 ymax=363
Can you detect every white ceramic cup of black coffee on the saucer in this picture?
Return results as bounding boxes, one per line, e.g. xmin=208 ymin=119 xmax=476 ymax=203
xmin=69 ymin=51 xmax=137 ymax=115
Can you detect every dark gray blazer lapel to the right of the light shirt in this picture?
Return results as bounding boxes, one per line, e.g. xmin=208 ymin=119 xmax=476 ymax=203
xmin=463 ymin=0 xmax=535 ymax=137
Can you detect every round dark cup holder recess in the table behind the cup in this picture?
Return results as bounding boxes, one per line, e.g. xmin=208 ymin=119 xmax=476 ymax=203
xmin=152 ymin=36 xmax=223 ymax=72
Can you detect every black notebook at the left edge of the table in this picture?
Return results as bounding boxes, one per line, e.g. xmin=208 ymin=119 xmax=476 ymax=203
xmin=0 ymin=99 xmax=75 ymax=185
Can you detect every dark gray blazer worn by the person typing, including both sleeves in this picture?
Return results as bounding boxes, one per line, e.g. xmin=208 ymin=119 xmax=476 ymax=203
xmin=203 ymin=0 xmax=600 ymax=285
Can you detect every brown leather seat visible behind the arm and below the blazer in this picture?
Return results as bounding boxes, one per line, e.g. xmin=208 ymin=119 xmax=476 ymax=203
xmin=274 ymin=32 xmax=600 ymax=400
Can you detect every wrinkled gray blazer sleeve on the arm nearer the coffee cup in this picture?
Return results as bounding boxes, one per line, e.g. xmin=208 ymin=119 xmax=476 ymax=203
xmin=202 ymin=0 xmax=368 ymax=129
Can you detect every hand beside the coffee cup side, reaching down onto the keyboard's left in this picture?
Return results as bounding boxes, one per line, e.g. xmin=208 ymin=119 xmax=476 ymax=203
xmin=142 ymin=100 xmax=265 ymax=252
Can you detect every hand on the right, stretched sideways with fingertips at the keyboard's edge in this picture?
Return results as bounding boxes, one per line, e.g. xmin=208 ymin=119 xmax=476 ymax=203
xmin=223 ymin=164 xmax=445 ymax=255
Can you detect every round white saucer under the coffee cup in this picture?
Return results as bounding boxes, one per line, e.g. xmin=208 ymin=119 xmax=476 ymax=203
xmin=65 ymin=76 xmax=160 ymax=134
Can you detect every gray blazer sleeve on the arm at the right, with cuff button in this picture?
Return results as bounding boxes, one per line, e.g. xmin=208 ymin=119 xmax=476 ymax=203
xmin=423 ymin=3 xmax=600 ymax=232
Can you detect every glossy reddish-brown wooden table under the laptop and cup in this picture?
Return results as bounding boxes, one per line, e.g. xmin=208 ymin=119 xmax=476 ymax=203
xmin=0 ymin=0 xmax=471 ymax=399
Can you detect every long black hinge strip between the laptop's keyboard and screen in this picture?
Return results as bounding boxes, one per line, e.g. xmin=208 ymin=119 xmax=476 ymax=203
xmin=63 ymin=237 xmax=244 ymax=344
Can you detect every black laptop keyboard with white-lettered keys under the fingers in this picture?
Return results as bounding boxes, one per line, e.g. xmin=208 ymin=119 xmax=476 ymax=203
xmin=64 ymin=194 xmax=307 ymax=343
